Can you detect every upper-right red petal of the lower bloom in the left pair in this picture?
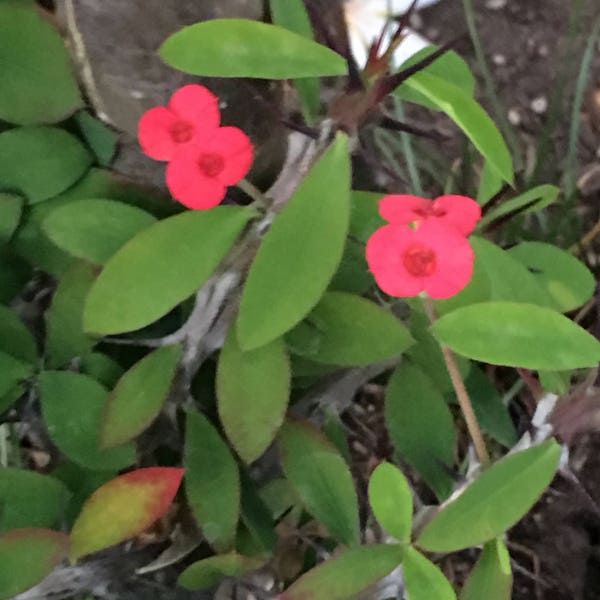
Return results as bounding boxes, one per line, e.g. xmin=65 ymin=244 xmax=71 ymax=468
xmin=206 ymin=127 xmax=254 ymax=185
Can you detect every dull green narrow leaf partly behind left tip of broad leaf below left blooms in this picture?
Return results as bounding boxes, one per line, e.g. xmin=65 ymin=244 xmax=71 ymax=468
xmin=45 ymin=263 xmax=96 ymax=368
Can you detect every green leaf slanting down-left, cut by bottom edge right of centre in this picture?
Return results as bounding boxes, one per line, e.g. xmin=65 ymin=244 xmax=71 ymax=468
xmin=280 ymin=544 xmax=404 ymax=600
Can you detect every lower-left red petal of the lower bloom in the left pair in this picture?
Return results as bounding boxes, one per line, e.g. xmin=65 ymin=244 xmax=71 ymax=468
xmin=166 ymin=146 xmax=227 ymax=210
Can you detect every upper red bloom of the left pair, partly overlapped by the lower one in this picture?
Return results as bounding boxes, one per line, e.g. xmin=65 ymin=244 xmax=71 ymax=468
xmin=138 ymin=85 xmax=221 ymax=161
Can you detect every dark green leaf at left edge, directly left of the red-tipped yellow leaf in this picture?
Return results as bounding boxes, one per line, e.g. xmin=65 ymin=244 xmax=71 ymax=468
xmin=0 ymin=468 xmax=69 ymax=531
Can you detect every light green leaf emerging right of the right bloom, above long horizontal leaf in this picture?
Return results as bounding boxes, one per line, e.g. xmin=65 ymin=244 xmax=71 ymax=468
xmin=471 ymin=236 xmax=551 ymax=306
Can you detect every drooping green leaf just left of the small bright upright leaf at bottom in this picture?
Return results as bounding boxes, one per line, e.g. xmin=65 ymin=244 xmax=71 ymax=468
xmin=279 ymin=421 xmax=359 ymax=546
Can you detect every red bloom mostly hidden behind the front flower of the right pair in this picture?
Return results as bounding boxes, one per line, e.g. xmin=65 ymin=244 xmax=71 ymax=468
xmin=379 ymin=195 xmax=481 ymax=235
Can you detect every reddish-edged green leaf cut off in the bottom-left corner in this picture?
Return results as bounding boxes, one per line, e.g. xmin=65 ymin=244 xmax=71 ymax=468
xmin=0 ymin=528 xmax=69 ymax=600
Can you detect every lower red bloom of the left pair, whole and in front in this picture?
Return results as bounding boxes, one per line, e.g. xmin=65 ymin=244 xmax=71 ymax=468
xmin=167 ymin=127 xmax=254 ymax=210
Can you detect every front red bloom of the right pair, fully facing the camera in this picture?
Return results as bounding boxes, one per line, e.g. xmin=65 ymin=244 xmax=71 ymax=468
xmin=367 ymin=219 xmax=475 ymax=299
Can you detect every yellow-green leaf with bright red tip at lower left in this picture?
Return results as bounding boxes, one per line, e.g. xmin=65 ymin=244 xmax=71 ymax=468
xmin=70 ymin=467 xmax=184 ymax=562
